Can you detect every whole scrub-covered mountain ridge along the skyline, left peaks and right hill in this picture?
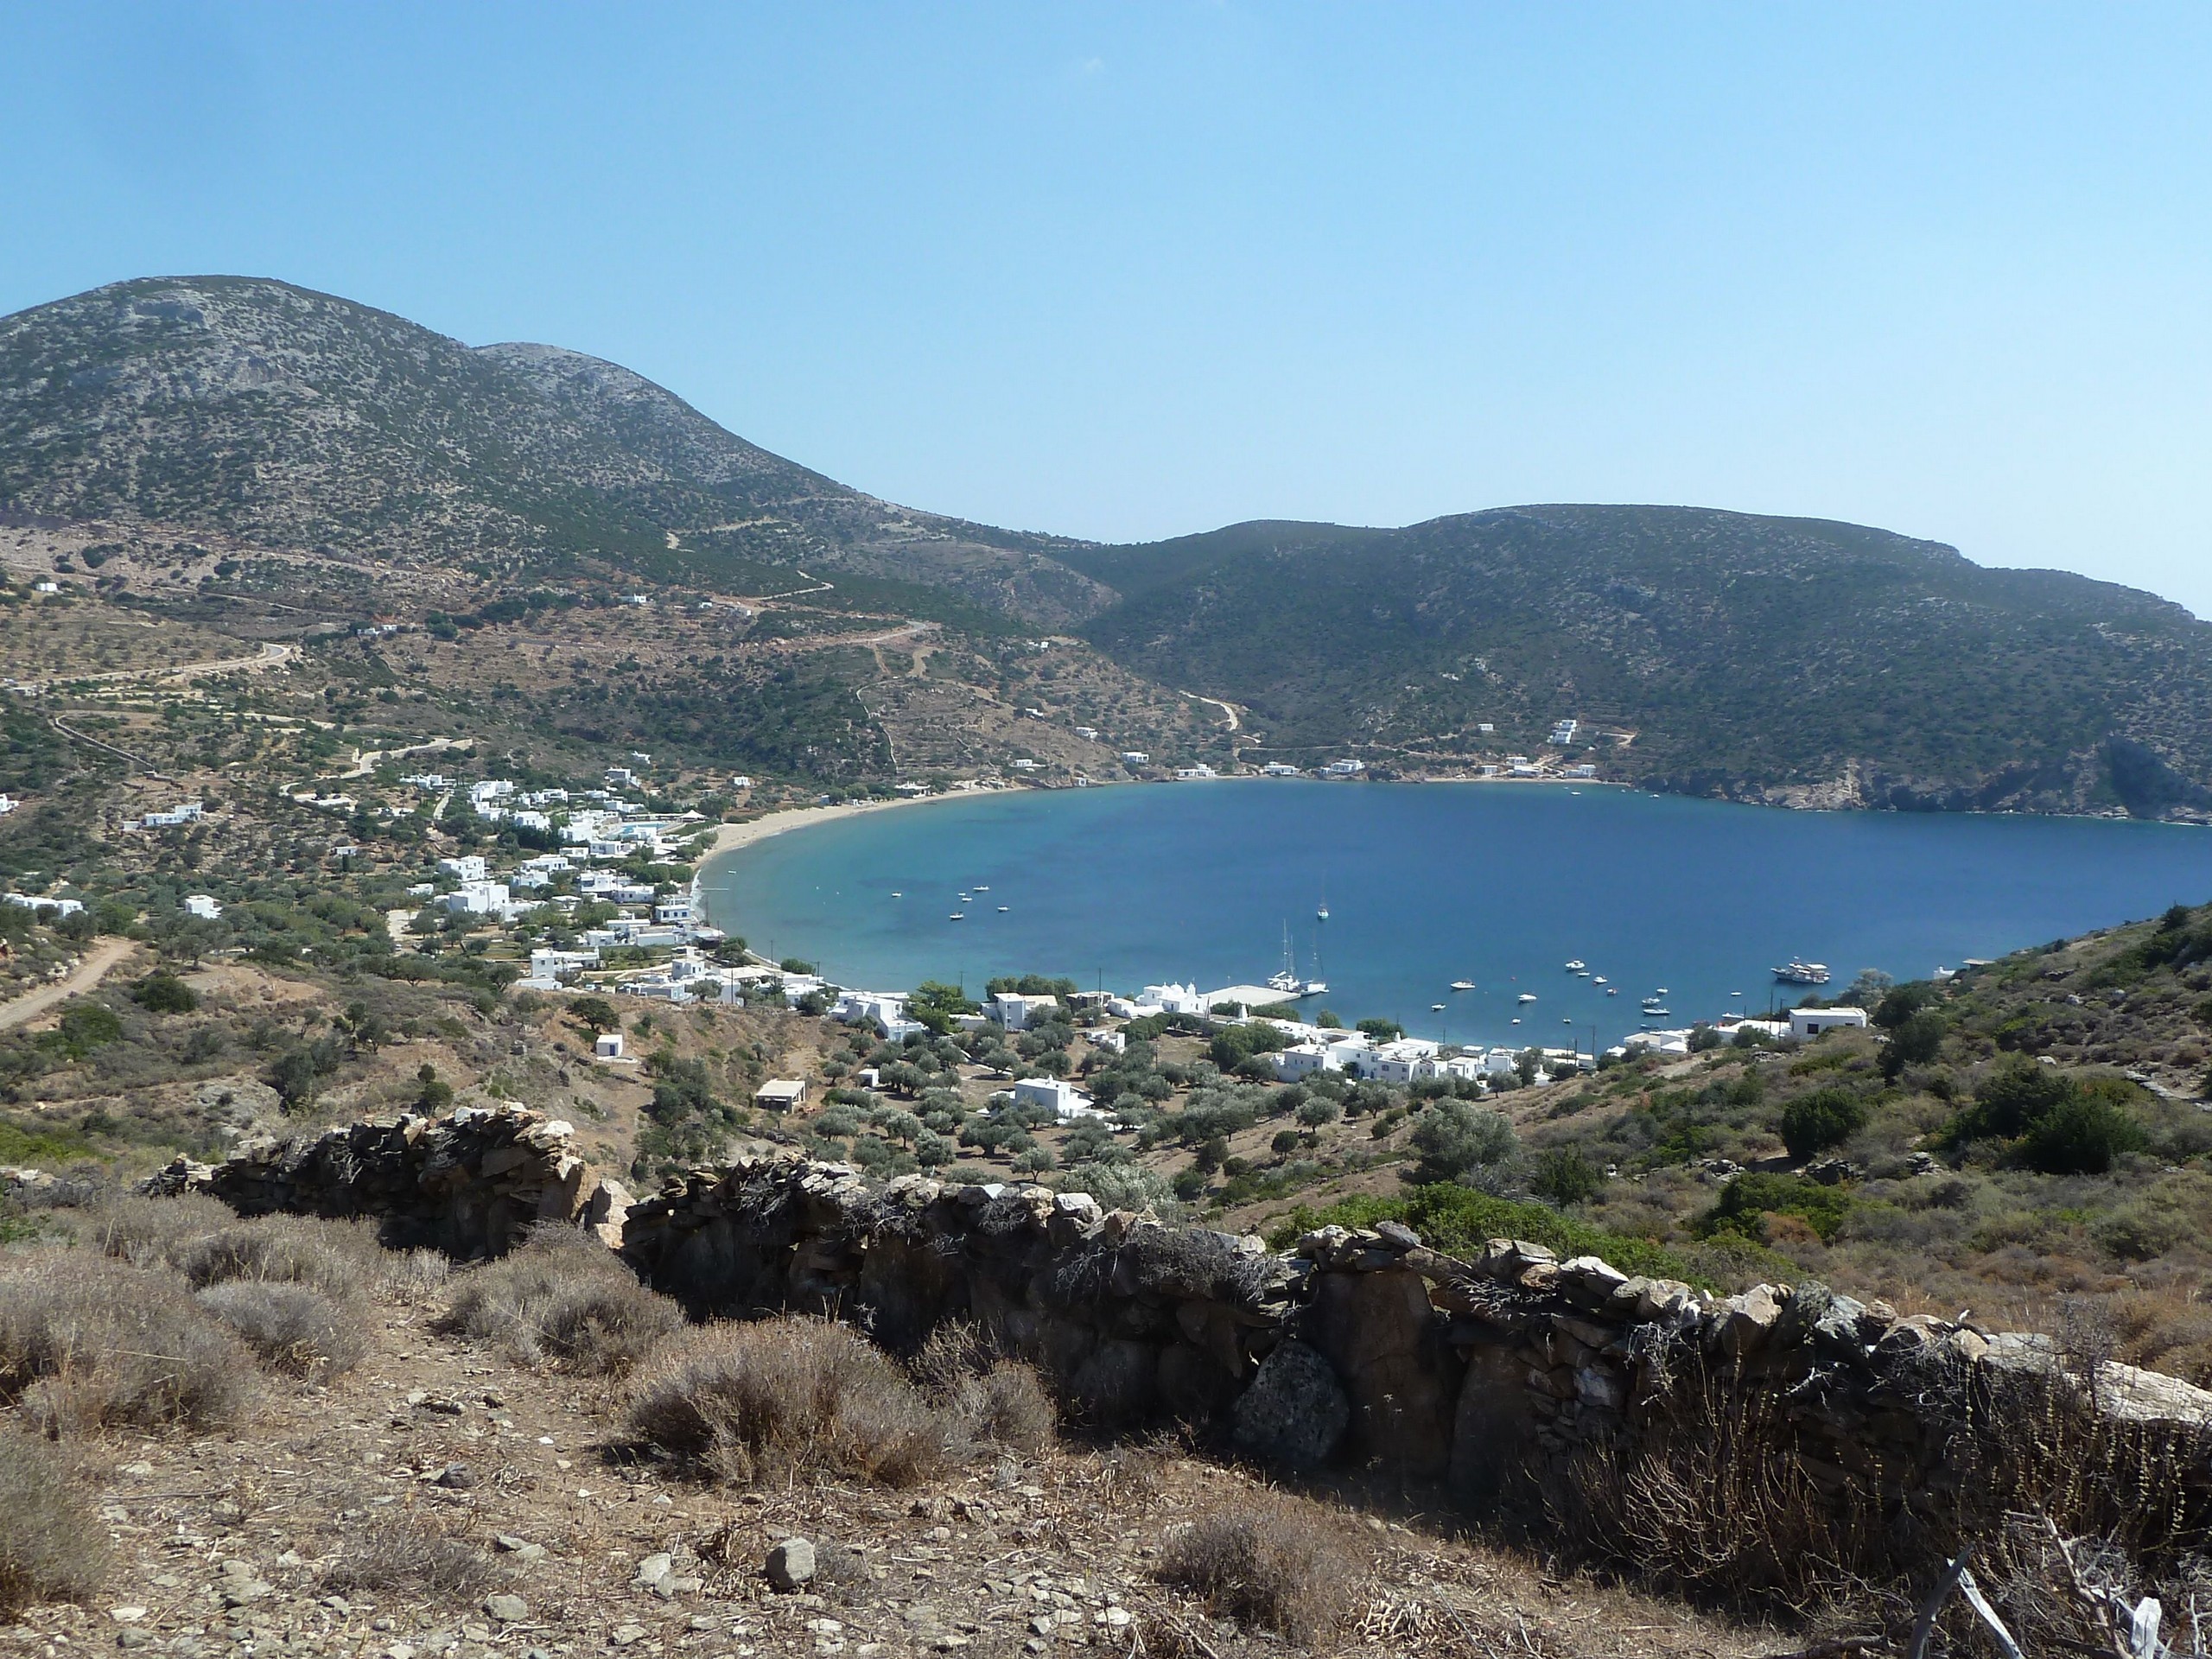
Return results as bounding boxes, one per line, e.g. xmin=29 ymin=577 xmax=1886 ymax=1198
xmin=13 ymin=276 xmax=2212 ymax=821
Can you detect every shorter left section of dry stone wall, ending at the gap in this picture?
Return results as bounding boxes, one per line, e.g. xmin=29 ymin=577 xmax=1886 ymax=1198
xmin=146 ymin=1106 xmax=628 ymax=1261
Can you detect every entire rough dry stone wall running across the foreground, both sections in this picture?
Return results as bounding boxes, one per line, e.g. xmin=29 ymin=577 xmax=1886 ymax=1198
xmin=155 ymin=1123 xmax=2212 ymax=1540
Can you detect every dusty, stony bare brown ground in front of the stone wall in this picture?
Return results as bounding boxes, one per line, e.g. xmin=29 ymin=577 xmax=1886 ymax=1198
xmin=0 ymin=1296 xmax=1794 ymax=1659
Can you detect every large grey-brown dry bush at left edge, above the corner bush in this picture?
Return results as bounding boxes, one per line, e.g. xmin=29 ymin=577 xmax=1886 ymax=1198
xmin=0 ymin=1255 xmax=254 ymax=1433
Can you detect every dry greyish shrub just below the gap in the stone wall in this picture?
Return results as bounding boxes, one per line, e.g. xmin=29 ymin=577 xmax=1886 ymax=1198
xmin=440 ymin=1228 xmax=683 ymax=1376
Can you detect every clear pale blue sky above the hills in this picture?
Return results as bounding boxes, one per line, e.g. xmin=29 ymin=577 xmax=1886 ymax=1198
xmin=0 ymin=0 xmax=2212 ymax=615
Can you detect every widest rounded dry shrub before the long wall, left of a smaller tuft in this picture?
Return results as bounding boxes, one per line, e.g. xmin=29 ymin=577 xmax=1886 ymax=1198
xmin=628 ymin=1319 xmax=947 ymax=1486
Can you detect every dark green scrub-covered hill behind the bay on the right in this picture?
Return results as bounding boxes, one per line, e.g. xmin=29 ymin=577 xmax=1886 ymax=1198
xmin=1062 ymin=506 xmax=2212 ymax=817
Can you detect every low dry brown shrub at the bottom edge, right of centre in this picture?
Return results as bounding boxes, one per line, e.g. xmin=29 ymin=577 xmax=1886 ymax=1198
xmin=1154 ymin=1491 xmax=1360 ymax=1643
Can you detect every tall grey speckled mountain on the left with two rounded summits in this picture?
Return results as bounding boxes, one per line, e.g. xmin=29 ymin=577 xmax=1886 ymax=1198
xmin=0 ymin=276 xmax=1106 ymax=621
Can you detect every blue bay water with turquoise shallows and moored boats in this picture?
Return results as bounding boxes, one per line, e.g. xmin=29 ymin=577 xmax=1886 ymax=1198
xmin=703 ymin=779 xmax=2212 ymax=1044
